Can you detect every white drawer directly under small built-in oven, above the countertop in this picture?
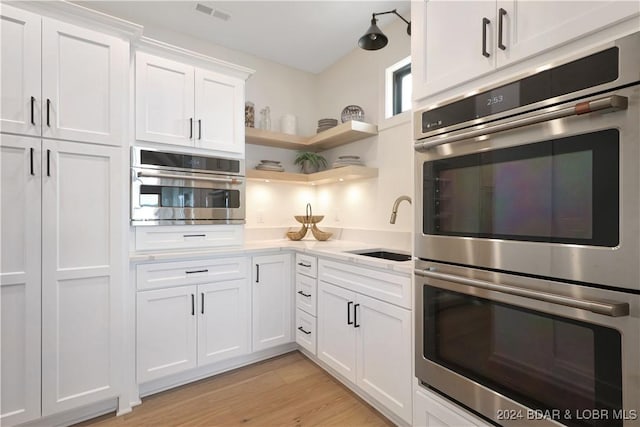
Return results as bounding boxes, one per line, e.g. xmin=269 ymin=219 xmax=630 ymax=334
xmin=135 ymin=224 xmax=244 ymax=251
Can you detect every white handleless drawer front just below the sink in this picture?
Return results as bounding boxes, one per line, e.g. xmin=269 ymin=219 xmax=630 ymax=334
xmin=318 ymin=259 xmax=411 ymax=309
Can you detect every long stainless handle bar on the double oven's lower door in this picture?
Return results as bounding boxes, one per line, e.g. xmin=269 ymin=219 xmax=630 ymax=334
xmin=414 ymin=268 xmax=629 ymax=317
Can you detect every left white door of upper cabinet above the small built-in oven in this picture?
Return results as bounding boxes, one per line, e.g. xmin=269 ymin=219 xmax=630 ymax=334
xmin=136 ymin=52 xmax=195 ymax=146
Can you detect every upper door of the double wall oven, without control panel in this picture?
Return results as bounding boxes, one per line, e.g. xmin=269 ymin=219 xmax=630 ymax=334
xmin=415 ymin=85 xmax=640 ymax=289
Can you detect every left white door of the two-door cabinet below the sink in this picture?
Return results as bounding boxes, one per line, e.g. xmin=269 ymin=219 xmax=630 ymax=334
xmin=317 ymin=281 xmax=358 ymax=383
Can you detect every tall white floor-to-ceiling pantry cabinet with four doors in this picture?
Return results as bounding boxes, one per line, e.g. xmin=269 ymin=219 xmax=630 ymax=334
xmin=0 ymin=4 xmax=129 ymax=426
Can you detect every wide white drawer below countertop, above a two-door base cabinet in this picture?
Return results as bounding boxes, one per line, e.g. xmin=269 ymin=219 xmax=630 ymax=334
xmin=136 ymin=257 xmax=248 ymax=290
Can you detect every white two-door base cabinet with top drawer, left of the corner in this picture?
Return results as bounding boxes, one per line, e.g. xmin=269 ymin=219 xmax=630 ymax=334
xmin=136 ymin=258 xmax=250 ymax=383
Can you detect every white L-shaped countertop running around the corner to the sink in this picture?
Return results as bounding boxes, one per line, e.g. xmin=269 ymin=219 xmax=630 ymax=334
xmin=129 ymin=239 xmax=413 ymax=274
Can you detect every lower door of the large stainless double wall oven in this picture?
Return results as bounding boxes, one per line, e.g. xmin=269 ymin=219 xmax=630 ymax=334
xmin=415 ymin=262 xmax=640 ymax=427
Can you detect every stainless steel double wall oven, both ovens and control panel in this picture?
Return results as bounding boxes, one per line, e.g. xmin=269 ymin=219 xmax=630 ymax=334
xmin=414 ymin=33 xmax=640 ymax=427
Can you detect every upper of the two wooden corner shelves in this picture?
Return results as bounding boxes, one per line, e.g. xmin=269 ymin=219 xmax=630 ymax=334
xmin=245 ymin=120 xmax=378 ymax=151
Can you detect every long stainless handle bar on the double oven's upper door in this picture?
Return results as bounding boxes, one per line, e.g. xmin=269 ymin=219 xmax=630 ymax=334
xmin=413 ymin=95 xmax=628 ymax=152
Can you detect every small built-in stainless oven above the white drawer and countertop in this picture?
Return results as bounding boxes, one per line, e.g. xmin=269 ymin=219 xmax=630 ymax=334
xmin=131 ymin=147 xmax=245 ymax=226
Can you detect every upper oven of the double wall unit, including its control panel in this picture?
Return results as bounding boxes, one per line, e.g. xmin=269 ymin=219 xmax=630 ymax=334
xmin=414 ymin=33 xmax=640 ymax=290
